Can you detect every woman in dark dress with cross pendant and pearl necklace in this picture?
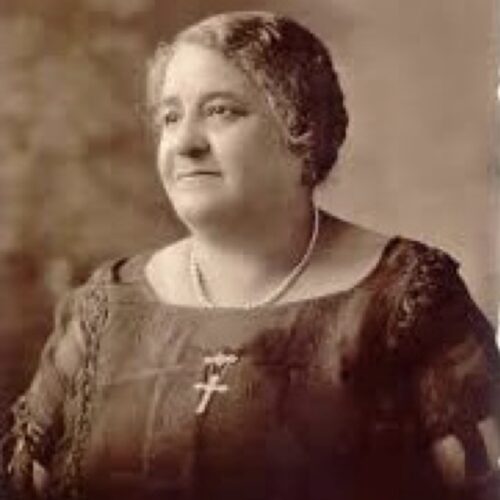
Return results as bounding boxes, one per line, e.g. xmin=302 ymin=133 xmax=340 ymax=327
xmin=0 ymin=8 xmax=499 ymax=500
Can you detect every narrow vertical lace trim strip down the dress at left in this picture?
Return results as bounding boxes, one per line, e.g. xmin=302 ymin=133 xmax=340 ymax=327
xmin=59 ymin=280 xmax=109 ymax=499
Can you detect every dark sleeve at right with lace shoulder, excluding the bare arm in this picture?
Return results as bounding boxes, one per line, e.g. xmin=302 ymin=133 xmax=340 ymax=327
xmin=387 ymin=247 xmax=499 ymax=439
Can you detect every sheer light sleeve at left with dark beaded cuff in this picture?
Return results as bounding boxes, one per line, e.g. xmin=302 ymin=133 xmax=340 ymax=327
xmin=0 ymin=268 xmax=107 ymax=499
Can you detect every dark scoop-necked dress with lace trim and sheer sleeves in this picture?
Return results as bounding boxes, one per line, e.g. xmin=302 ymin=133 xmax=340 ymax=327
xmin=2 ymin=238 xmax=500 ymax=500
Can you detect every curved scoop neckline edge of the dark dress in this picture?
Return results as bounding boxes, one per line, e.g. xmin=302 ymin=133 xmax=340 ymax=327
xmin=136 ymin=235 xmax=404 ymax=314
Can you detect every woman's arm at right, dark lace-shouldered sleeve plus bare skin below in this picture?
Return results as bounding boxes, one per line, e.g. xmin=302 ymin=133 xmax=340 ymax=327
xmin=396 ymin=248 xmax=500 ymax=500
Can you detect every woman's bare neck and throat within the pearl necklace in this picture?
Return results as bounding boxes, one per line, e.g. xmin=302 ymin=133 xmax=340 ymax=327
xmin=191 ymin=197 xmax=314 ymax=306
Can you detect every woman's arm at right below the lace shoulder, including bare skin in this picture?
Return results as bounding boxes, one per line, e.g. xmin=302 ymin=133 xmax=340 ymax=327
xmin=417 ymin=318 xmax=500 ymax=500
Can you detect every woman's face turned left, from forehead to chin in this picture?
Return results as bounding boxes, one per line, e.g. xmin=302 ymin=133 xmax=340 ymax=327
xmin=158 ymin=43 xmax=304 ymax=230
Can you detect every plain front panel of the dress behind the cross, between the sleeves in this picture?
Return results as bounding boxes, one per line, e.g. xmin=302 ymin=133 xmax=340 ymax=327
xmin=58 ymin=292 xmax=412 ymax=500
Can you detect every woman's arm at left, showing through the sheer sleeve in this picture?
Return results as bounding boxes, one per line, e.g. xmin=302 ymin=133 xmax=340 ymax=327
xmin=2 ymin=292 xmax=85 ymax=498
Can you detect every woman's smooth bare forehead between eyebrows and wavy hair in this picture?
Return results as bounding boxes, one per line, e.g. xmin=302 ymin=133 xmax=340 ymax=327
xmin=161 ymin=42 xmax=262 ymax=100
